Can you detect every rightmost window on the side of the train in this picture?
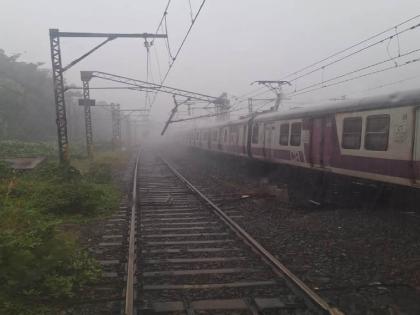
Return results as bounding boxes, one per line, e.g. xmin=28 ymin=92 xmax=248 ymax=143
xmin=365 ymin=115 xmax=390 ymax=151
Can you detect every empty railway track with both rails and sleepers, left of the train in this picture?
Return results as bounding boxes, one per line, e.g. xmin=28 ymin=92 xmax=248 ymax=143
xmin=125 ymin=152 xmax=342 ymax=315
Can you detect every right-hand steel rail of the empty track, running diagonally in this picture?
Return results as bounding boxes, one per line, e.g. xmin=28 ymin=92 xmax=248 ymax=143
xmin=160 ymin=156 xmax=344 ymax=315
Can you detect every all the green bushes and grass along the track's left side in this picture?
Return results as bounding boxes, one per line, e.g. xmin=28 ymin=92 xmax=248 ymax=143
xmin=0 ymin=143 xmax=124 ymax=314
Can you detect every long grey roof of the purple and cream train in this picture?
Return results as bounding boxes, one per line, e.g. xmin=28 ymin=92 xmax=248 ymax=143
xmin=255 ymin=89 xmax=420 ymax=121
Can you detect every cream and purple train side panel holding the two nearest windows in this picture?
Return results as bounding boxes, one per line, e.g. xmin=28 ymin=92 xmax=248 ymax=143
xmin=331 ymin=106 xmax=415 ymax=185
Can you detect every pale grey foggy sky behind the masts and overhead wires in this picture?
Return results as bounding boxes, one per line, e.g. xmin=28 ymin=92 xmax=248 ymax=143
xmin=0 ymin=0 xmax=420 ymax=119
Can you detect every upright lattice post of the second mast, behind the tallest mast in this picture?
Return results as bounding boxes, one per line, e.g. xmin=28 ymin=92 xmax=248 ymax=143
xmin=79 ymin=71 xmax=95 ymax=159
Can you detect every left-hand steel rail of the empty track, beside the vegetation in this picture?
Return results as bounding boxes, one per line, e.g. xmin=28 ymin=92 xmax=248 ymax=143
xmin=125 ymin=154 xmax=140 ymax=315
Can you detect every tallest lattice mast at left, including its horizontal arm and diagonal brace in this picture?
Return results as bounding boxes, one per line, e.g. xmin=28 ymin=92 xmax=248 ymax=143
xmin=49 ymin=29 xmax=167 ymax=164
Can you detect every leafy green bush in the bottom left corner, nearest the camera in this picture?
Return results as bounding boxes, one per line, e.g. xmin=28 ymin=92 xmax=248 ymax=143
xmin=0 ymin=208 xmax=100 ymax=314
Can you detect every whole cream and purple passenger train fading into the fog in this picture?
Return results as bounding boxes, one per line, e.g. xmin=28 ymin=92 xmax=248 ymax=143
xmin=182 ymin=90 xmax=420 ymax=188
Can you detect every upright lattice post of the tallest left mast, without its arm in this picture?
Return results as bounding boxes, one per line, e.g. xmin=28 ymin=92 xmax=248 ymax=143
xmin=50 ymin=29 xmax=69 ymax=164
